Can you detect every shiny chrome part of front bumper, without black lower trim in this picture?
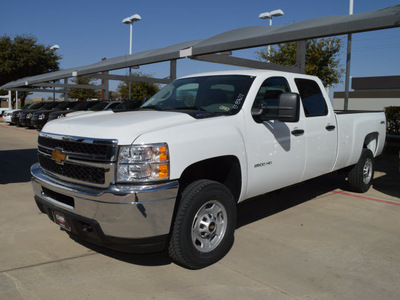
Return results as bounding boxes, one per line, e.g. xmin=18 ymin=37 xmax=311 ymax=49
xmin=31 ymin=164 xmax=179 ymax=239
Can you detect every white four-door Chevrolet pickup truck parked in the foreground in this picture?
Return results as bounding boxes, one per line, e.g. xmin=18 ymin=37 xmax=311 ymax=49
xmin=31 ymin=70 xmax=386 ymax=269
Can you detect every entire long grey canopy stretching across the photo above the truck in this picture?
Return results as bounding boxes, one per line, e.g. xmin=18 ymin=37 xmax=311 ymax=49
xmin=0 ymin=5 xmax=400 ymax=90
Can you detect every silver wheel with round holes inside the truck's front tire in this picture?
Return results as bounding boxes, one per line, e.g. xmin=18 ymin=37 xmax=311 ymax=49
xmin=192 ymin=200 xmax=228 ymax=252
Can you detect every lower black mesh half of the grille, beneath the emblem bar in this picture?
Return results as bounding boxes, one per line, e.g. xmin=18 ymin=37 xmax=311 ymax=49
xmin=39 ymin=155 xmax=106 ymax=184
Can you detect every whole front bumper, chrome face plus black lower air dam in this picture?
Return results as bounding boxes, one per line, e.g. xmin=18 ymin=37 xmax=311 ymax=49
xmin=31 ymin=164 xmax=179 ymax=252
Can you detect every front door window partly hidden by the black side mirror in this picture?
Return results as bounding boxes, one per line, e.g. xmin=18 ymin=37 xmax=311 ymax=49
xmin=253 ymin=77 xmax=290 ymax=117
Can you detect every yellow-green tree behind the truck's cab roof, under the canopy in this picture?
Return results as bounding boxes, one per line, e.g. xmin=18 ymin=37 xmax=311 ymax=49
xmin=256 ymin=38 xmax=343 ymax=86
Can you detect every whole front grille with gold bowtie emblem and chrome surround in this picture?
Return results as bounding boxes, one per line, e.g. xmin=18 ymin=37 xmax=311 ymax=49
xmin=38 ymin=132 xmax=118 ymax=187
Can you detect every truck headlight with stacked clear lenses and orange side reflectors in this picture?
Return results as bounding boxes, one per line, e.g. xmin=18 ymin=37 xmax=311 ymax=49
xmin=117 ymin=144 xmax=169 ymax=182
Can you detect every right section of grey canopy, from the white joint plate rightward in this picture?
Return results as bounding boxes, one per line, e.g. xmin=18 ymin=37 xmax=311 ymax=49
xmin=192 ymin=5 xmax=400 ymax=55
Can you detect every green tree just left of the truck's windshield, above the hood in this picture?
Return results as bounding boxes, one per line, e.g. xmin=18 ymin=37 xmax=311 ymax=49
xmin=118 ymin=72 xmax=160 ymax=100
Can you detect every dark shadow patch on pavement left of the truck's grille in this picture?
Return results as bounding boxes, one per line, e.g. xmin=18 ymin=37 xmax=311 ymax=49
xmin=0 ymin=149 xmax=38 ymax=184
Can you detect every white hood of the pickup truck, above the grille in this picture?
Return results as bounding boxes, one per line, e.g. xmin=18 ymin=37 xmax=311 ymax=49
xmin=42 ymin=111 xmax=196 ymax=145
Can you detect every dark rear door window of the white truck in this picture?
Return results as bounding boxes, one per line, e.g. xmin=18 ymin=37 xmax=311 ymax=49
xmin=294 ymin=78 xmax=328 ymax=117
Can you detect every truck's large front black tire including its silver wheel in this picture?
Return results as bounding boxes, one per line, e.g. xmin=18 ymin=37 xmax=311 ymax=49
xmin=168 ymin=180 xmax=236 ymax=269
